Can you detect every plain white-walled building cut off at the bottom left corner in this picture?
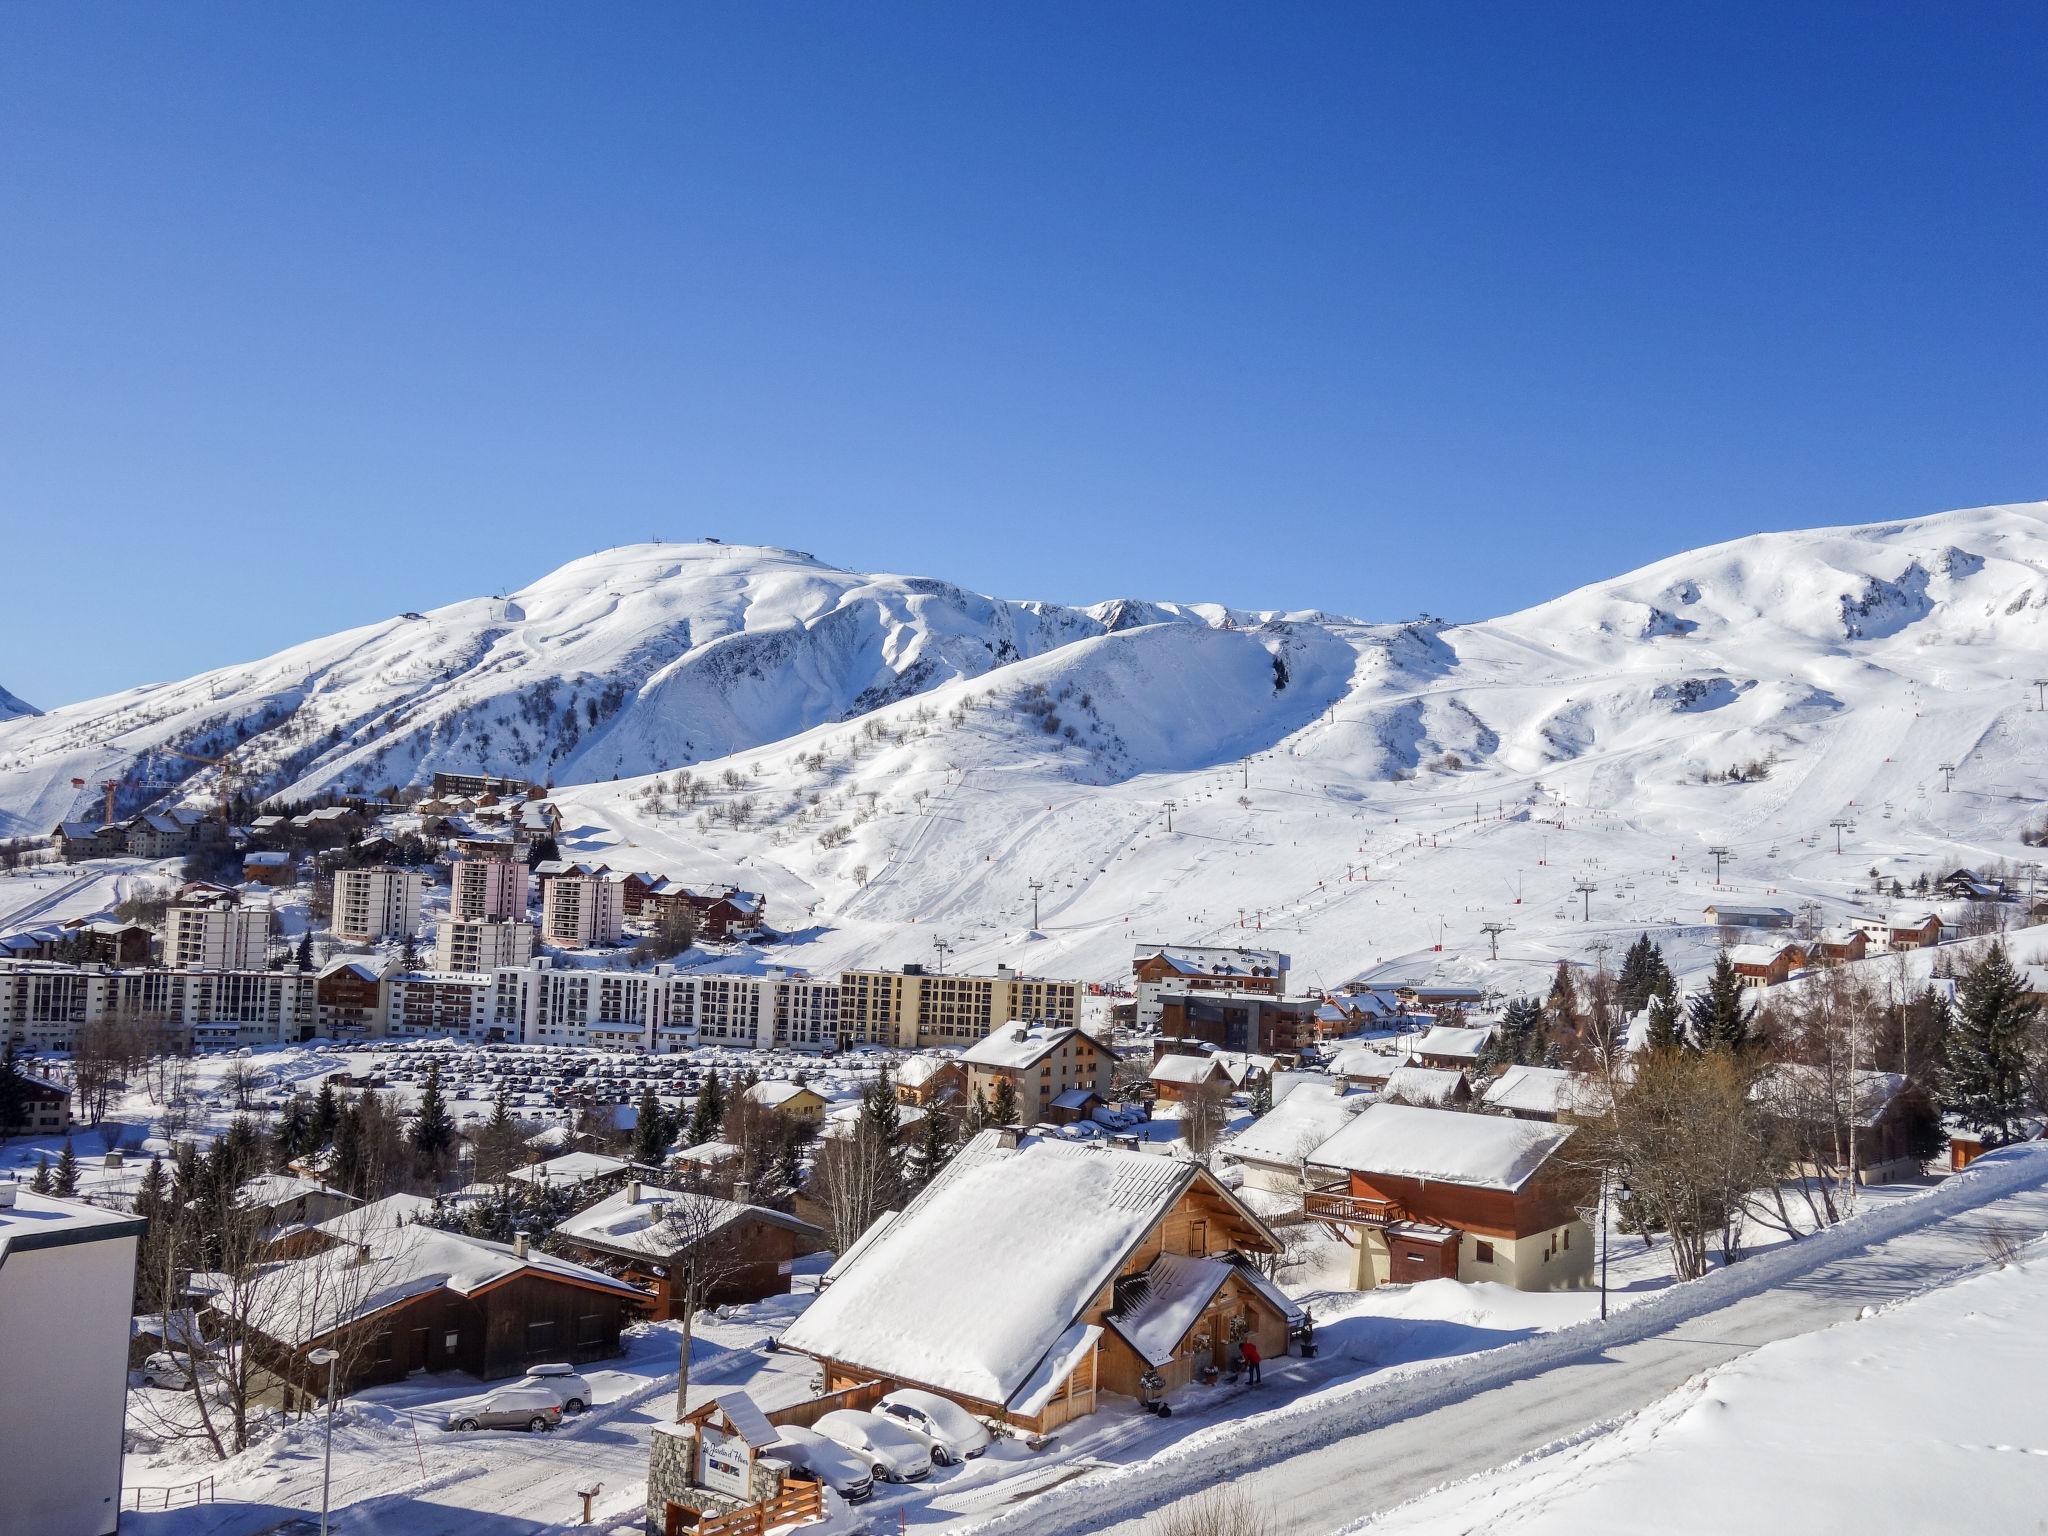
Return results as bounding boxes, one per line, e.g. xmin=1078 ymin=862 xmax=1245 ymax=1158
xmin=0 ymin=1182 xmax=145 ymax=1536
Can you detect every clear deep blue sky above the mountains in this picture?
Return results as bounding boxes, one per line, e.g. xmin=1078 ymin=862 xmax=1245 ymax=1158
xmin=0 ymin=4 xmax=2048 ymax=707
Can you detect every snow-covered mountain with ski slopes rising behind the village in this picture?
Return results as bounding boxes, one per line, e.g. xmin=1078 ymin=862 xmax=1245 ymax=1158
xmin=0 ymin=506 xmax=2048 ymax=983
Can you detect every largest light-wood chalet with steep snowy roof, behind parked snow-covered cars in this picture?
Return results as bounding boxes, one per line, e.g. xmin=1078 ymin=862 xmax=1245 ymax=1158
xmin=782 ymin=1130 xmax=1300 ymax=1434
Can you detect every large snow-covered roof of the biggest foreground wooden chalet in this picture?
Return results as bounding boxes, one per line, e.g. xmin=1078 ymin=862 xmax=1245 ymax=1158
xmin=782 ymin=1130 xmax=1272 ymax=1411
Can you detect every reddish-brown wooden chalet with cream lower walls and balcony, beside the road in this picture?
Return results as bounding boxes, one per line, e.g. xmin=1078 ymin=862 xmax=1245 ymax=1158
xmin=1303 ymin=1104 xmax=1593 ymax=1290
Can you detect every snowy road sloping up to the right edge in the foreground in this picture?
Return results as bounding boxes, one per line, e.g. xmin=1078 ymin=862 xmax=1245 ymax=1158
xmin=966 ymin=1153 xmax=2048 ymax=1536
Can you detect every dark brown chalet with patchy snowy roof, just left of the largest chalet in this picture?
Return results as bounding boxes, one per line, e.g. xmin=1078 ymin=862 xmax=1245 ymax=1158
xmin=555 ymin=1180 xmax=825 ymax=1319
